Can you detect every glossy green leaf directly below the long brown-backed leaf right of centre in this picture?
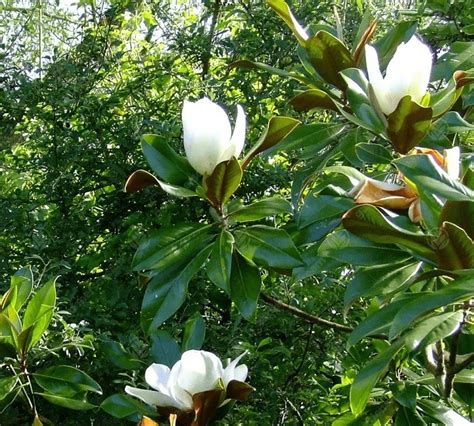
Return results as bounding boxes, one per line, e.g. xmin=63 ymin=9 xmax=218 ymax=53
xmin=318 ymin=230 xmax=411 ymax=266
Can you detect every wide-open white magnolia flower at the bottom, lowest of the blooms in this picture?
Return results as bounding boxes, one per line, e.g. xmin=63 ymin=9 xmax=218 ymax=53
xmin=125 ymin=350 xmax=248 ymax=411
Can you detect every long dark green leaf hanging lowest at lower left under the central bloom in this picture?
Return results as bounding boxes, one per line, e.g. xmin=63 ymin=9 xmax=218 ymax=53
xmin=141 ymin=245 xmax=212 ymax=333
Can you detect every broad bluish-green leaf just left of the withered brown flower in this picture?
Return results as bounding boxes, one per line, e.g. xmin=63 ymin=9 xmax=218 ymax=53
xmin=297 ymin=192 xmax=354 ymax=228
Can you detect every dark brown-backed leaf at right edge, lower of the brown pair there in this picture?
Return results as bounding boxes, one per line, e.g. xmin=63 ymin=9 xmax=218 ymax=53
xmin=435 ymin=221 xmax=474 ymax=271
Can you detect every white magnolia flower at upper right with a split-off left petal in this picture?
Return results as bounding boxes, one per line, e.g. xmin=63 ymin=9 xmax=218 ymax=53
xmin=365 ymin=36 xmax=432 ymax=115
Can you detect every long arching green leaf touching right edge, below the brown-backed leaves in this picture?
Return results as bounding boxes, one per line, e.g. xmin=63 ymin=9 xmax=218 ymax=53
xmin=389 ymin=276 xmax=474 ymax=339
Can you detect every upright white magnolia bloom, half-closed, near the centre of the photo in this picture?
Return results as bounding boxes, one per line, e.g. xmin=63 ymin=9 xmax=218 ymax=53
xmin=182 ymin=98 xmax=246 ymax=175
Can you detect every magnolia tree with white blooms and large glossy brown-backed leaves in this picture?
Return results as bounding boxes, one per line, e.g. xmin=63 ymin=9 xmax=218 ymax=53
xmin=102 ymin=0 xmax=474 ymax=425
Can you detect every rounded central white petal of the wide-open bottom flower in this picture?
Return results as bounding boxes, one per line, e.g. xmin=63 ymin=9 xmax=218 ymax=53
xmin=178 ymin=350 xmax=224 ymax=395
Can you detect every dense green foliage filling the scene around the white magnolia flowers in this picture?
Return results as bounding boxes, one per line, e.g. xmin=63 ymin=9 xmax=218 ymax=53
xmin=0 ymin=0 xmax=474 ymax=425
